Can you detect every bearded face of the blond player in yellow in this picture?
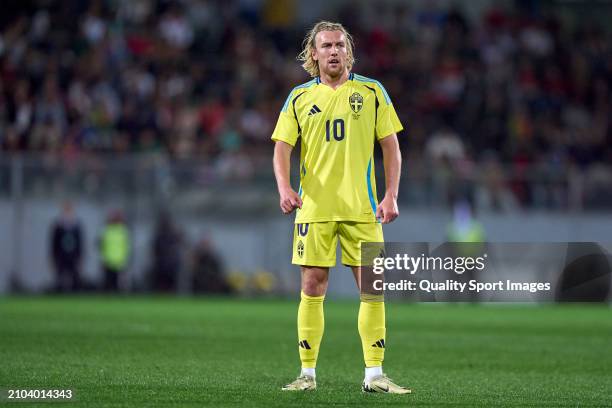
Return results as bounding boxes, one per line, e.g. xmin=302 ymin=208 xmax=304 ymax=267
xmin=312 ymin=31 xmax=348 ymax=78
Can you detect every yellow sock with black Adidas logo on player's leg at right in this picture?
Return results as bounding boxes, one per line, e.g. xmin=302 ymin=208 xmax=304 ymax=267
xmin=358 ymin=295 xmax=386 ymax=367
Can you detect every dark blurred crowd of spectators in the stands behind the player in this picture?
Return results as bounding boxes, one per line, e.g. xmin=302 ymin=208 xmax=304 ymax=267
xmin=0 ymin=0 xmax=612 ymax=208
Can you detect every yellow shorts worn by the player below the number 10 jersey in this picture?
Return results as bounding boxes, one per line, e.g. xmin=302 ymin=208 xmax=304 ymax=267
xmin=292 ymin=221 xmax=384 ymax=267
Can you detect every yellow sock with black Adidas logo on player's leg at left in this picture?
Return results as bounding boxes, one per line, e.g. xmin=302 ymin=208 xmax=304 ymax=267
xmin=298 ymin=292 xmax=326 ymax=368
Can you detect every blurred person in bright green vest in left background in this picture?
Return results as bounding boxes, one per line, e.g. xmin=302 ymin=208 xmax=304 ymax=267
xmin=100 ymin=210 xmax=130 ymax=291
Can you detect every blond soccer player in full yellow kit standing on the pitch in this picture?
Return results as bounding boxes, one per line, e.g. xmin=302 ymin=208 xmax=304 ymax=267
xmin=272 ymin=21 xmax=410 ymax=394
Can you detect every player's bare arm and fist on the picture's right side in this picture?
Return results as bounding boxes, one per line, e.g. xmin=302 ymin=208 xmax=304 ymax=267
xmin=376 ymin=133 xmax=402 ymax=224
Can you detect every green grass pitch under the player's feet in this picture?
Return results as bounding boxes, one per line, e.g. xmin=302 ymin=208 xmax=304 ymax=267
xmin=0 ymin=297 xmax=612 ymax=407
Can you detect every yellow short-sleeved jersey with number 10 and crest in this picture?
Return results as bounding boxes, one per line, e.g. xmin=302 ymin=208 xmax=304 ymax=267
xmin=272 ymin=73 xmax=403 ymax=223
